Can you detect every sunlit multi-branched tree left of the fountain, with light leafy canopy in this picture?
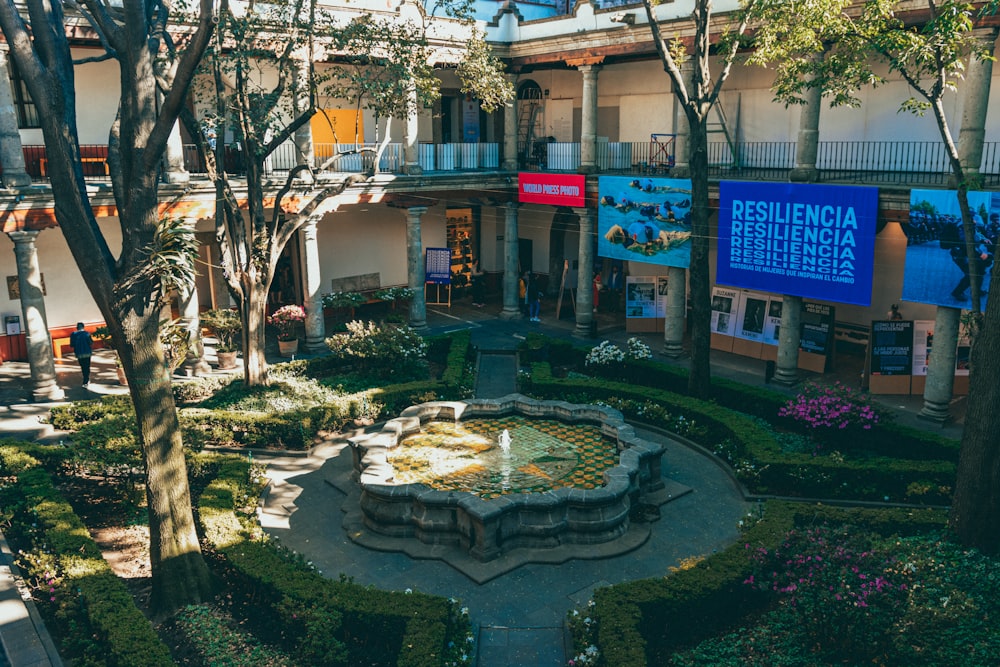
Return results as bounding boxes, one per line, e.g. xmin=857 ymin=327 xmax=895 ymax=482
xmin=184 ymin=0 xmax=513 ymax=385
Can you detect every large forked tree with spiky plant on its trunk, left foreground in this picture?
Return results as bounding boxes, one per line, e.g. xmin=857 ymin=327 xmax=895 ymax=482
xmin=0 ymin=0 xmax=217 ymax=611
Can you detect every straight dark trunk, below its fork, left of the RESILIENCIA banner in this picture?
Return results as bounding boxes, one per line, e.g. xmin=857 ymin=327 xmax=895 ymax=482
xmin=688 ymin=113 xmax=712 ymax=398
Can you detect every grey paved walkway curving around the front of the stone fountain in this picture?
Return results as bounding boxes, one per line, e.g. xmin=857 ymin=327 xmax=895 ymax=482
xmin=260 ymin=428 xmax=750 ymax=667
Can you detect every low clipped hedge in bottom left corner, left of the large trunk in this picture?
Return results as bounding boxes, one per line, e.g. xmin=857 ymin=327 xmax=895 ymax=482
xmin=0 ymin=441 xmax=174 ymax=667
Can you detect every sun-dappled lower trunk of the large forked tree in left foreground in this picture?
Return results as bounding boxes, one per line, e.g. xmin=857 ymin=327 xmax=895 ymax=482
xmin=119 ymin=309 xmax=211 ymax=611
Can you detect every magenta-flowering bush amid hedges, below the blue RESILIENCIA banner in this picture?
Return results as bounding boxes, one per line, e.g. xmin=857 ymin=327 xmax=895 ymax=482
xmin=778 ymin=382 xmax=882 ymax=446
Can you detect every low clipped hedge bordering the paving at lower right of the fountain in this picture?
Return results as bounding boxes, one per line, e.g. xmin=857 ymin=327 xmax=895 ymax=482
xmin=590 ymin=501 xmax=947 ymax=667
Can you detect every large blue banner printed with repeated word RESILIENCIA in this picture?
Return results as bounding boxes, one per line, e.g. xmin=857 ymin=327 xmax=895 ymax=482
xmin=716 ymin=181 xmax=878 ymax=306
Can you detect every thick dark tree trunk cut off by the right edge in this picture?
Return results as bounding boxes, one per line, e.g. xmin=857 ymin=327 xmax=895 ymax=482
xmin=949 ymin=290 xmax=1000 ymax=556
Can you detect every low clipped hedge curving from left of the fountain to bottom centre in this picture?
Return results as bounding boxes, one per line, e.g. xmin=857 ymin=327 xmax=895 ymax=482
xmin=199 ymin=456 xmax=467 ymax=667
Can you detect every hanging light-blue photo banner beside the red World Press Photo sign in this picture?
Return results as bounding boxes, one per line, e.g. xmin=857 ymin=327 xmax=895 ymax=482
xmin=597 ymin=176 xmax=691 ymax=269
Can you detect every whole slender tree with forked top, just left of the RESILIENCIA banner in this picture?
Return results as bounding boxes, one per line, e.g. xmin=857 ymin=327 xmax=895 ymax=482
xmin=643 ymin=0 xmax=761 ymax=398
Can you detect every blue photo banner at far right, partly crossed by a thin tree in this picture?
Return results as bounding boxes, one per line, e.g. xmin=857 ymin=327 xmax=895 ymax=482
xmin=903 ymin=190 xmax=1000 ymax=309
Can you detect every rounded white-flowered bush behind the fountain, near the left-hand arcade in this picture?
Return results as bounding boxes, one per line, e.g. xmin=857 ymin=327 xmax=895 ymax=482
xmin=326 ymin=320 xmax=427 ymax=377
